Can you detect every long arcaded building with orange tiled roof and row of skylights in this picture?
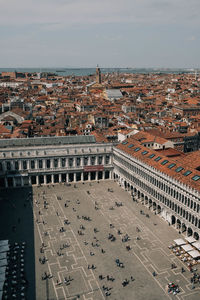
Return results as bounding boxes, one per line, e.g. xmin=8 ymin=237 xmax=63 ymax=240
xmin=113 ymin=142 xmax=200 ymax=239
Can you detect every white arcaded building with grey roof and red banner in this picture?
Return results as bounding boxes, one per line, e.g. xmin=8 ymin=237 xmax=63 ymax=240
xmin=0 ymin=136 xmax=113 ymax=188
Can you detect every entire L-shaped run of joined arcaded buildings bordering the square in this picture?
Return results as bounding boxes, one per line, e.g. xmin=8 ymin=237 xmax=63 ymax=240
xmin=0 ymin=136 xmax=200 ymax=239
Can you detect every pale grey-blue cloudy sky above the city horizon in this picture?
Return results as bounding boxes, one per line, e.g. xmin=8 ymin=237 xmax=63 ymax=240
xmin=0 ymin=0 xmax=200 ymax=68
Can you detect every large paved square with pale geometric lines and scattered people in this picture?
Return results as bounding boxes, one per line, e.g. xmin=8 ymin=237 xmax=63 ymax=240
xmin=0 ymin=181 xmax=200 ymax=300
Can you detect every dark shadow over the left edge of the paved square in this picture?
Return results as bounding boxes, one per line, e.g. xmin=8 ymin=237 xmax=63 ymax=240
xmin=0 ymin=187 xmax=35 ymax=300
